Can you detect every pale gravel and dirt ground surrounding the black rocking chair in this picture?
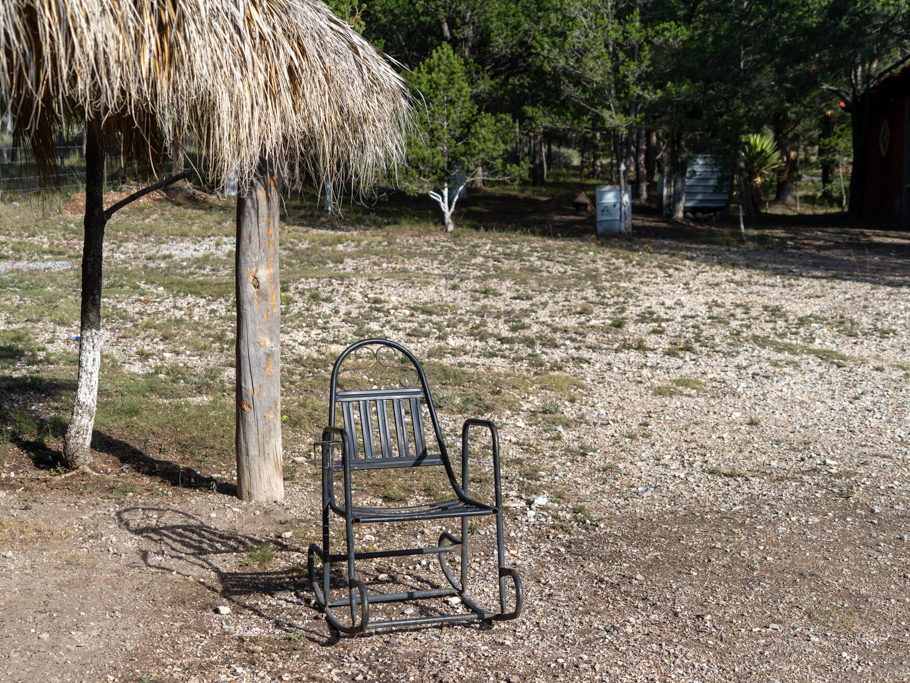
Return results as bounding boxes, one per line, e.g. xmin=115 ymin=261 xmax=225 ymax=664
xmin=0 ymin=212 xmax=910 ymax=682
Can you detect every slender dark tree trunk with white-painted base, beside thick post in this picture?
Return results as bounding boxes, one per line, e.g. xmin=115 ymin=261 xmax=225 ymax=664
xmin=63 ymin=121 xmax=107 ymax=469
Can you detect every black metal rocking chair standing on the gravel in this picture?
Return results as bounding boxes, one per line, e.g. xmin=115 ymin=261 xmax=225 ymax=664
xmin=307 ymin=339 xmax=524 ymax=634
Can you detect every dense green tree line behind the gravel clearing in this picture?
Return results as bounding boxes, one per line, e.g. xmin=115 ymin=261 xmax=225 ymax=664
xmin=334 ymin=0 xmax=910 ymax=219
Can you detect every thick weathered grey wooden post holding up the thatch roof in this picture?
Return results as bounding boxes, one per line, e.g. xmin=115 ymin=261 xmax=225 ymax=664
xmin=235 ymin=165 xmax=284 ymax=503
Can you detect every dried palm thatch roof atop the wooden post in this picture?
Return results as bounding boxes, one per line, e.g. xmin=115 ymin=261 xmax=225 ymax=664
xmin=0 ymin=0 xmax=408 ymax=187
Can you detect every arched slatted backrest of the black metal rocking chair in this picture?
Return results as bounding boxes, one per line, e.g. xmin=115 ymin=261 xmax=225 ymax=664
xmin=329 ymin=339 xmax=449 ymax=469
